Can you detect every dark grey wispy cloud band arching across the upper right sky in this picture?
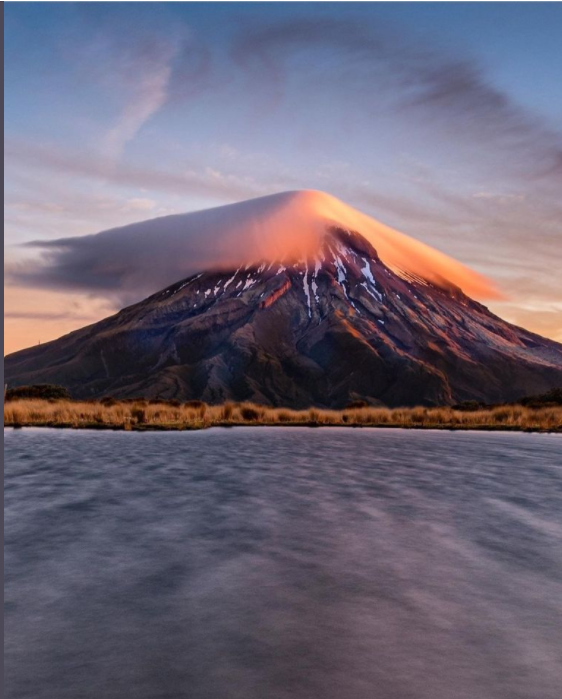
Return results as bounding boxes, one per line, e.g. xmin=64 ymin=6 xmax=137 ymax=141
xmin=232 ymin=18 xmax=562 ymax=177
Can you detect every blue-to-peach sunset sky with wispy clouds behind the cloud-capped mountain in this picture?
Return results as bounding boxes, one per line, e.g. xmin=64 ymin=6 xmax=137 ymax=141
xmin=4 ymin=2 xmax=562 ymax=352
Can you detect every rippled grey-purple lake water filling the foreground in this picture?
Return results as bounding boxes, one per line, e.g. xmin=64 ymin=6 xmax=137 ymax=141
xmin=4 ymin=427 xmax=562 ymax=699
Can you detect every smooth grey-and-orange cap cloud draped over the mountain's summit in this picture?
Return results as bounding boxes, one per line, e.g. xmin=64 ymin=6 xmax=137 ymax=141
xmin=13 ymin=191 xmax=497 ymax=300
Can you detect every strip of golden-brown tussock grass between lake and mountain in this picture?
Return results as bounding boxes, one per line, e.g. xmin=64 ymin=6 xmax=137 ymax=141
xmin=4 ymin=399 xmax=562 ymax=432
